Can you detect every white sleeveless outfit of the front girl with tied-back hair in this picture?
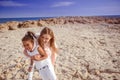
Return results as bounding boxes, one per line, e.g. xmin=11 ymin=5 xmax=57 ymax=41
xmin=27 ymin=46 xmax=57 ymax=80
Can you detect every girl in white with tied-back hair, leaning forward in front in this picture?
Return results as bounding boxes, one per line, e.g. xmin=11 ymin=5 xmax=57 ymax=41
xmin=22 ymin=32 xmax=57 ymax=80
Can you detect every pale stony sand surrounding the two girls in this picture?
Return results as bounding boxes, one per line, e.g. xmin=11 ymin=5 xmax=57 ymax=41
xmin=0 ymin=16 xmax=120 ymax=80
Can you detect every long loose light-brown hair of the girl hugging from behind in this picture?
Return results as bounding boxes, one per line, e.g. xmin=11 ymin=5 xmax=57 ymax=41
xmin=38 ymin=27 xmax=57 ymax=53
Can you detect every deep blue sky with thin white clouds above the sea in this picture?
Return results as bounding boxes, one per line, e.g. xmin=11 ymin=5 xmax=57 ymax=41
xmin=0 ymin=0 xmax=120 ymax=18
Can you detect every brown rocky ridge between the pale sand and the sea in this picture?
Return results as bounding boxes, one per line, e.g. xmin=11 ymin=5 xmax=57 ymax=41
xmin=0 ymin=17 xmax=120 ymax=30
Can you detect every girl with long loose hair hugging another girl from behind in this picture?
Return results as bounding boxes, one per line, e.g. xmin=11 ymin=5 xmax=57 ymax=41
xmin=38 ymin=27 xmax=58 ymax=65
